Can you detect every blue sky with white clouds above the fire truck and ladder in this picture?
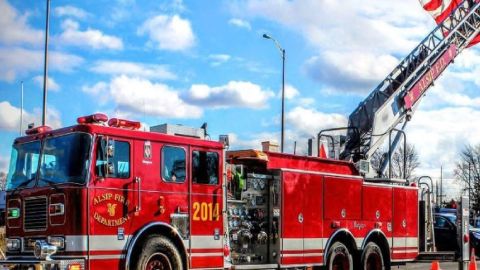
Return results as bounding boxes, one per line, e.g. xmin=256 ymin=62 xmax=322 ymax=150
xmin=0 ymin=0 xmax=480 ymax=198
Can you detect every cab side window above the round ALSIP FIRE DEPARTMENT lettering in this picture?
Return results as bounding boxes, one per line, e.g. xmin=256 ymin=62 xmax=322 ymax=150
xmin=95 ymin=140 xmax=130 ymax=179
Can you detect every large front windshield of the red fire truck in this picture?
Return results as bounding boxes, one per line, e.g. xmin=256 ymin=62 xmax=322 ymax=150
xmin=7 ymin=133 xmax=92 ymax=190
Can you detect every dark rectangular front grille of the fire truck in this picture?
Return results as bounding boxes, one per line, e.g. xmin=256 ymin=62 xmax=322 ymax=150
xmin=23 ymin=197 xmax=48 ymax=231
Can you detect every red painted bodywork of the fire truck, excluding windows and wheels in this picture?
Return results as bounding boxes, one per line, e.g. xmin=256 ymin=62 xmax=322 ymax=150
xmin=7 ymin=125 xmax=418 ymax=269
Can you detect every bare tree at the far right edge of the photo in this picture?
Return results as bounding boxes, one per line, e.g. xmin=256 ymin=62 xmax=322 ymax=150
xmin=454 ymin=144 xmax=480 ymax=211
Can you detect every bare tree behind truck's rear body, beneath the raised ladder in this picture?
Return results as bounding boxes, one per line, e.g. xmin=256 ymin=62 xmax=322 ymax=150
xmin=371 ymin=143 xmax=420 ymax=180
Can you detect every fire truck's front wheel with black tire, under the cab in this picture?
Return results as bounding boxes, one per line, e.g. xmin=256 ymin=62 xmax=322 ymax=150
xmin=134 ymin=235 xmax=184 ymax=270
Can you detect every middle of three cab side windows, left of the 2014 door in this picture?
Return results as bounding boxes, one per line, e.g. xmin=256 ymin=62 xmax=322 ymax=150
xmin=161 ymin=146 xmax=187 ymax=183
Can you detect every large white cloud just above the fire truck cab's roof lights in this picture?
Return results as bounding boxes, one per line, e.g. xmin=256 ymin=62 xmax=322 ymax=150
xmin=82 ymin=75 xmax=203 ymax=118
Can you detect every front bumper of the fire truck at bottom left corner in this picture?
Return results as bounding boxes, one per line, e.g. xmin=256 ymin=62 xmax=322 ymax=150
xmin=0 ymin=258 xmax=85 ymax=270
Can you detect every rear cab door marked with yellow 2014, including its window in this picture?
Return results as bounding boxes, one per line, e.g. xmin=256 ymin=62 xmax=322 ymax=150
xmin=190 ymin=147 xmax=223 ymax=268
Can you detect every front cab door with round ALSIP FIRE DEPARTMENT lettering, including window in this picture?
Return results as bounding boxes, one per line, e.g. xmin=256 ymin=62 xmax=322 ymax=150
xmin=86 ymin=136 xmax=138 ymax=269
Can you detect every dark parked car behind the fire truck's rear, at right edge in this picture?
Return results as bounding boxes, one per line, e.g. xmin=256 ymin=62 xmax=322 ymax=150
xmin=434 ymin=213 xmax=480 ymax=256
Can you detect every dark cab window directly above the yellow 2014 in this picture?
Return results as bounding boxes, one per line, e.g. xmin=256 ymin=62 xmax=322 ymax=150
xmin=192 ymin=151 xmax=219 ymax=185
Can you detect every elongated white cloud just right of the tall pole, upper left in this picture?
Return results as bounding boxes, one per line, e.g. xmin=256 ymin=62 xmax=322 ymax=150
xmin=58 ymin=19 xmax=123 ymax=50
